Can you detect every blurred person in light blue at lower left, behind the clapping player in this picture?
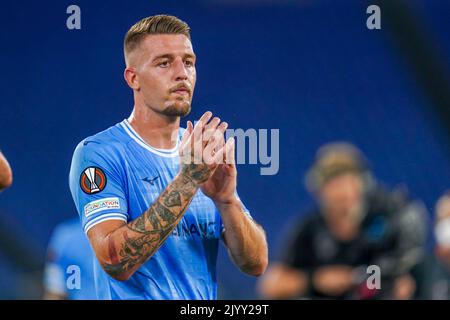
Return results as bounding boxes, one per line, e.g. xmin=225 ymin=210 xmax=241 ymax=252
xmin=44 ymin=217 xmax=97 ymax=300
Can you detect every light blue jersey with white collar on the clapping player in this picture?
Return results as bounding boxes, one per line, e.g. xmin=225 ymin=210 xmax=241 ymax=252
xmin=70 ymin=120 xmax=248 ymax=299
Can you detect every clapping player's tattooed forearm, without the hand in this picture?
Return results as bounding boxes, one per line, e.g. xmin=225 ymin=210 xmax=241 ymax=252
xmin=102 ymin=173 xmax=198 ymax=280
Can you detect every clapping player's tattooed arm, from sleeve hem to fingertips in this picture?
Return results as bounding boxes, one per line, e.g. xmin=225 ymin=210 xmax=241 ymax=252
xmin=88 ymin=113 xmax=226 ymax=280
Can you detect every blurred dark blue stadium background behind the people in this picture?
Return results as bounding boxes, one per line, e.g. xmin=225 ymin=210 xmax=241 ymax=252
xmin=0 ymin=0 xmax=450 ymax=299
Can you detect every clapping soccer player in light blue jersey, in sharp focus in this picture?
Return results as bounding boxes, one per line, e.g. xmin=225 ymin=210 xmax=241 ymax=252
xmin=70 ymin=15 xmax=268 ymax=299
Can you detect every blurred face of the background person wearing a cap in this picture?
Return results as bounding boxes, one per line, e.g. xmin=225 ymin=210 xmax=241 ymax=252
xmin=320 ymin=173 xmax=363 ymax=224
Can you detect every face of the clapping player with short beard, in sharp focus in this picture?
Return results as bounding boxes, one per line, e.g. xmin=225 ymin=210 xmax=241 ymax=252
xmin=136 ymin=34 xmax=196 ymax=117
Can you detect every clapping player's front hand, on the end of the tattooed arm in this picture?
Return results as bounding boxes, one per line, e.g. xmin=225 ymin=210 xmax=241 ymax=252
xmin=180 ymin=111 xmax=228 ymax=186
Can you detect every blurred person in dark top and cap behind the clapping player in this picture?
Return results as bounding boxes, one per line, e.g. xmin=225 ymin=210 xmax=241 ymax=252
xmin=258 ymin=143 xmax=426 ymax=299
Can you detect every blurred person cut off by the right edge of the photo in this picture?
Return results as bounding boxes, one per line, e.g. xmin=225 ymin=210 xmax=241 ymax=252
xmin=427 ymin=191 xmax=450 ymax=300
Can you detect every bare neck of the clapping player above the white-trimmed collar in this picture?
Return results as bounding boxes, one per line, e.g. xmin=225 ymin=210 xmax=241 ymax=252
xmin=128 ymin=107 xmax=180 ymax=149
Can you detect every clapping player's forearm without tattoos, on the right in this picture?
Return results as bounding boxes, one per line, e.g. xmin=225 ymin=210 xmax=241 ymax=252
xmin=218 ymin=200 xmax=268 ymax=276
